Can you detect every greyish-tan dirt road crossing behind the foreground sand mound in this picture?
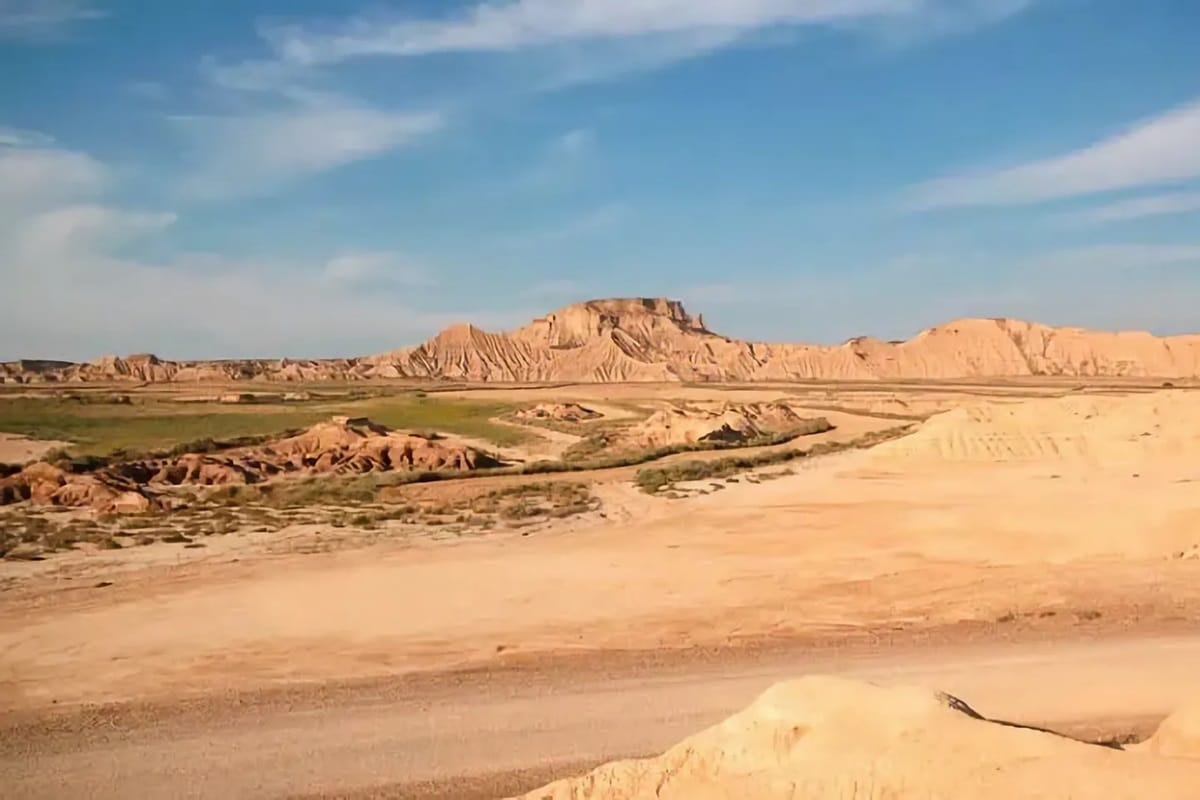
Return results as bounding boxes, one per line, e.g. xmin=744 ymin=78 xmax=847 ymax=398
xmin=0 ymin=633 xmax=1200 ymax=799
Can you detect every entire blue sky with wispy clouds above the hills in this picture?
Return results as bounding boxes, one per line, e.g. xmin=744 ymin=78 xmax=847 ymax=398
xmin=0 ymin=0 xmax=1200 ymax=359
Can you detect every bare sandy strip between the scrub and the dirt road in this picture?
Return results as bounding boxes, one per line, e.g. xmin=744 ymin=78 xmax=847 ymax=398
xmin=0 ymin=443 xmax=1200 ymax=708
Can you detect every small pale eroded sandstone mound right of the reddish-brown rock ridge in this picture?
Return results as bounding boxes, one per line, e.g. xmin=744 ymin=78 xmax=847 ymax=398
xmin=618 ymin=403 xmax=830 ymax=450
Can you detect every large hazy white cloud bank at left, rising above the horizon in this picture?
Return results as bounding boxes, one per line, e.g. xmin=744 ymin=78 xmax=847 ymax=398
xmin=0 ymin=140 xmax=499 ymax=359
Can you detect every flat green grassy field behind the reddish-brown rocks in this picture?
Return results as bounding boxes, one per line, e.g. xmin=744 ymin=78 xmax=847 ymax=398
xmin=0 ymin=393 xmax=527 ymax=456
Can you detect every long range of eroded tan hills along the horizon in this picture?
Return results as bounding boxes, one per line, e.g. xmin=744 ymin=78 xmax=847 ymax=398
xmin=9 ymin=299 xmax=1200 ymax=383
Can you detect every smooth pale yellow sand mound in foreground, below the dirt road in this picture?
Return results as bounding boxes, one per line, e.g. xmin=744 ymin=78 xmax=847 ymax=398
xmin=526 ymin=676 xmax=1200 ymax=800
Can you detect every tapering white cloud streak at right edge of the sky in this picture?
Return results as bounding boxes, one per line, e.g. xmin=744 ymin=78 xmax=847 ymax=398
xmin=908 ymin=100 xmax=1200 ymax=209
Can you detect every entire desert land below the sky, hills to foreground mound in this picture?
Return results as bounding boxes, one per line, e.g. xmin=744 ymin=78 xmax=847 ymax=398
xmin=0 ymin=299 xmax=1200 ymax=800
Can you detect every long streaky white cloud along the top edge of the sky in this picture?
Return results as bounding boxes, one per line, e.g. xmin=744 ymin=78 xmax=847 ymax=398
xmin=264 ymin=0 xmax=1027 ymax=65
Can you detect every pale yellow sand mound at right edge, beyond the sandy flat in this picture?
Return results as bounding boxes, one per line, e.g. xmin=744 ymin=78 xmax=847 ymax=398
xmin=871 ymin=391 xmax=1200 ymax=470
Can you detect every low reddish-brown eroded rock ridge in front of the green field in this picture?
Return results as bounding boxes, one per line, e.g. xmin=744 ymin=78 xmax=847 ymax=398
xmin=0 ymin=417 xmax=500 ymax=512
